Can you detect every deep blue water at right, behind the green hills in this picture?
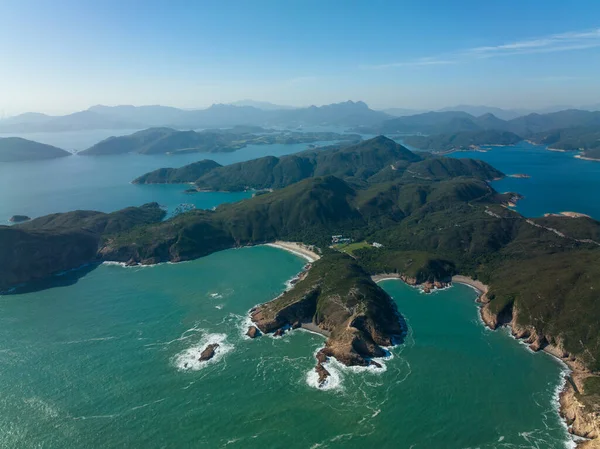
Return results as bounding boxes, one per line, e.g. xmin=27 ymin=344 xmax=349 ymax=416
xmin=451 ymin=142 xmax=600 ymax=219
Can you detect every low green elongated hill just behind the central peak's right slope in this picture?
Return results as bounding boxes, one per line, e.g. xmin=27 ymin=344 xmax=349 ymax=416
xmin=404 ymin=130 xmax=523 ymax=153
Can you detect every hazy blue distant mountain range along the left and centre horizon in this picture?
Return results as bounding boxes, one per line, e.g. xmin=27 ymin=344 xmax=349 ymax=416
xmin=0 ymin=101 xmax=391 ymax=133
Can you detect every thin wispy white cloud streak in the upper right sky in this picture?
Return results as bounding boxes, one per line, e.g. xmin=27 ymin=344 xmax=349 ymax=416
xmin=362 ymin=28 xmax=600 ymax=69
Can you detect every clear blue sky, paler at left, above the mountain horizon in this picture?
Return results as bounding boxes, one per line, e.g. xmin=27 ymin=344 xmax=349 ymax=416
xmin=0 ymin=0 xmax=600 ymax=117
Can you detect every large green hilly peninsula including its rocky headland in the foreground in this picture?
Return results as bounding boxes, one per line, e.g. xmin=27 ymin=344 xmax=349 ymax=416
xmin=0 ymin=136 xmax=600 ymax=437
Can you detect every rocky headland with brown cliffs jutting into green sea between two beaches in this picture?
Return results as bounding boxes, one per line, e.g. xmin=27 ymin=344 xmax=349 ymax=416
xmin=251 ymin=253 xmax=403 ymax=377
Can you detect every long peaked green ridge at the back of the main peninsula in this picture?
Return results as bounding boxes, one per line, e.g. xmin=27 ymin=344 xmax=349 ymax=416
xmin=134 ymin=136 xmax=502 ymax=191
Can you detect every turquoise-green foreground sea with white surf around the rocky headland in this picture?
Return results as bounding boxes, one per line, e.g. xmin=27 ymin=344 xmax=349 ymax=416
xmin=0 ymin=247 xmax=567 ymax=449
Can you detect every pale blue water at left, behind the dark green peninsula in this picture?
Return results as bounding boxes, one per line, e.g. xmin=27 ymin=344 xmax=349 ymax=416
xmin=0 ymin=131 xmax=331 ymax=224
